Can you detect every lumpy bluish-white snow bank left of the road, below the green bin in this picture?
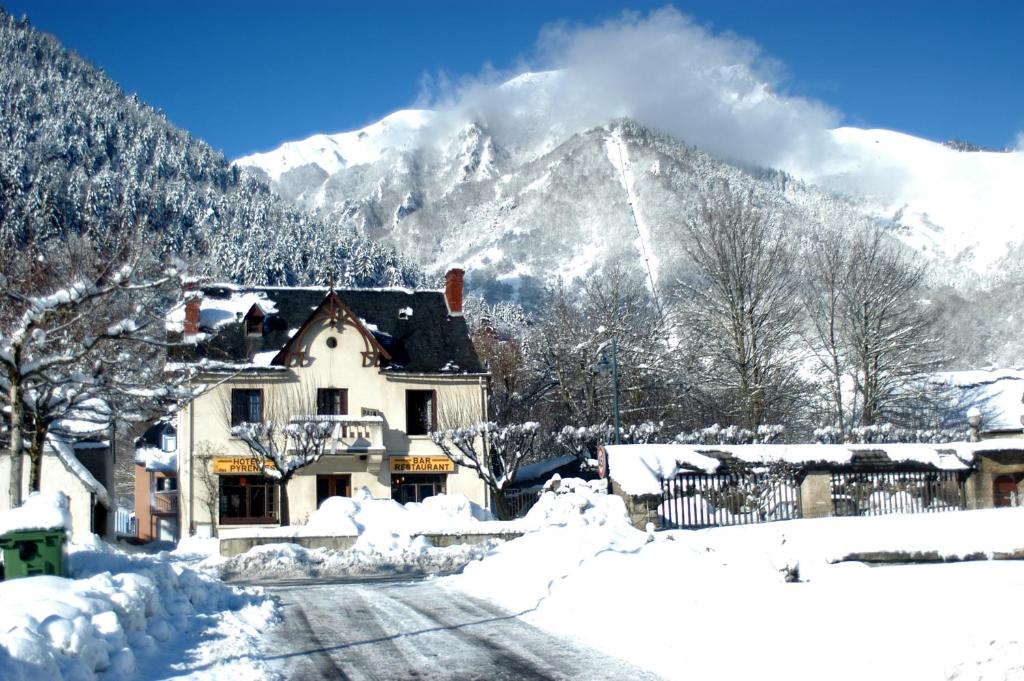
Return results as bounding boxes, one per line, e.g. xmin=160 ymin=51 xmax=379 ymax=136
xmin=0 ymin=536 xmax=280 ymax=681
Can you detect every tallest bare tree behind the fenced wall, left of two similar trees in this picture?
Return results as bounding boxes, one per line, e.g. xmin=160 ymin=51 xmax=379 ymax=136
xmin=676 ymin=189 xmax=803 ymax=430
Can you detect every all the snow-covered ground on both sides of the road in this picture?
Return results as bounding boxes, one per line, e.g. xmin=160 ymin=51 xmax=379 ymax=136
xmin=8 ymin=479 xmax=1024 ymax=681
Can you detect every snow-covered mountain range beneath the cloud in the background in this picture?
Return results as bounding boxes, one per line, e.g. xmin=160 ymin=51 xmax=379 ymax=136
xmin=237 ymin=72 xmax=1024 ymax=296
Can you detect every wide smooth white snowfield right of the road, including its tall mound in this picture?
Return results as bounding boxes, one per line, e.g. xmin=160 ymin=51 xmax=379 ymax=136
xmin=449 ymin=481 xmax=1024 ymax=681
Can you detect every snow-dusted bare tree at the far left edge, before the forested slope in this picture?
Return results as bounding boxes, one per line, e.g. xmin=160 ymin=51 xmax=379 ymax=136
xmin=0 ymin=232 xmax=188 ymax=506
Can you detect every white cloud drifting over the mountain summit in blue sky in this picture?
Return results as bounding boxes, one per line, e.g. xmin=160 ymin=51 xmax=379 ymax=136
xmin=415 ymin=8 xmax=839 ymax=168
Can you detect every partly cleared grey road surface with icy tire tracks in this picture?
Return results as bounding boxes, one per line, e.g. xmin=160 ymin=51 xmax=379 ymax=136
xmin=253 ymin=580 xmax=658 ymax=681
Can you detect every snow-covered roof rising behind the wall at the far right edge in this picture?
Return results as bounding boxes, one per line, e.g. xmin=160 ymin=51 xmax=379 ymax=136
xmin=932 ymin=368 xmax=1024 ymax=432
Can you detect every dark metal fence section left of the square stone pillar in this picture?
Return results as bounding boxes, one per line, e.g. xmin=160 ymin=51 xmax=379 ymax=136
xmin=658 ymin=472 xmax=801 ymax=528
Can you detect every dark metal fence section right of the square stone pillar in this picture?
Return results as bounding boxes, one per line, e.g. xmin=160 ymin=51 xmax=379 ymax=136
xmin=831 ymin=470 xmax=967 ymax=515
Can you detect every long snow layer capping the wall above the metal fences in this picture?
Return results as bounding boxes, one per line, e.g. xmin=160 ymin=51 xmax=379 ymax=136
xmin=604 ymin=437 xmax=1024 ymax=495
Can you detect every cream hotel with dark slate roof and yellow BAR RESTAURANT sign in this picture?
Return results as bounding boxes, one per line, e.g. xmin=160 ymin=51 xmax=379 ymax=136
xmin=169 ymin=267 xmax=487 ymax=534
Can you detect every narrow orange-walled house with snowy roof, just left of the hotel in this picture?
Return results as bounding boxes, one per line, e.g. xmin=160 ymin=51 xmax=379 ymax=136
xmin=135 ymin=422 xmax=180 ymax=542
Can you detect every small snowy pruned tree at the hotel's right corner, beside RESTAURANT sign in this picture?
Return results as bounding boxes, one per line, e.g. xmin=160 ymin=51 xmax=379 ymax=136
xmin=430 ymin=400 xmax=540 ymax=520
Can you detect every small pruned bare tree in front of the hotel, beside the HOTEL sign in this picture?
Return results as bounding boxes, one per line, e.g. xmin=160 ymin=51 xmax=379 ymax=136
xmin=222 ymin=384 xmax=331 ymax=525
